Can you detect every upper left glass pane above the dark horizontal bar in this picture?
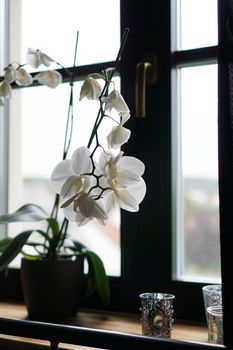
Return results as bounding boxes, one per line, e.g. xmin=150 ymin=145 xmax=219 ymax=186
xmin=11 ymin=0 xmax=120 ymax=66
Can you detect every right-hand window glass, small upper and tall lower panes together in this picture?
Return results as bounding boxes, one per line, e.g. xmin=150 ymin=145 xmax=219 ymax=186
xmin=172 ymin=0 xmax=221 ymax=283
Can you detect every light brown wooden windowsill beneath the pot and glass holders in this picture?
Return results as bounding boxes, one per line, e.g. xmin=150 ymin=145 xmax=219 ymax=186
xmin=0 ymin=302 xmax=208 ymax=350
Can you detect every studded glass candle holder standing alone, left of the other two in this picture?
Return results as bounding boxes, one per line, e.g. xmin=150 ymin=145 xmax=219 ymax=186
xmin=140 ymin=292 xmax=175 ymax=338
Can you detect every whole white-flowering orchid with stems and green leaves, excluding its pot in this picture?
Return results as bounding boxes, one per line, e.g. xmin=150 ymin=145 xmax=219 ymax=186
xmin=0 ymin=30 xmax=146 ymax=303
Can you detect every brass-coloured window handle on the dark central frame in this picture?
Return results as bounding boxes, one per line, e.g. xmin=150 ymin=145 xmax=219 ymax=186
xmin=135 ymin=55 xmax=158 ymax=118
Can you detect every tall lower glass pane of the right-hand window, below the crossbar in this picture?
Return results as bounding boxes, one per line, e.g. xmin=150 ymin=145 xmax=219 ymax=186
xmin=178 ymin=65 xmax=220 ymax=279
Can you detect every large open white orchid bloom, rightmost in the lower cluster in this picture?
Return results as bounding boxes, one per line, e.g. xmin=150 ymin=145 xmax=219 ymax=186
xmin=99 ymin=152 xmax=146 ymax=212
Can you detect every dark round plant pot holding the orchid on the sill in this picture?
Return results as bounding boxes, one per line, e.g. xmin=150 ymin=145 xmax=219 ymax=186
xmin=21 ymin=254 xmax=84 ymax=320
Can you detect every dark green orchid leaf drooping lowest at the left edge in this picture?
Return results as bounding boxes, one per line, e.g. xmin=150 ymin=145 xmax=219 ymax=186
xmin=0 ymin=230 xmax=34 ymax=271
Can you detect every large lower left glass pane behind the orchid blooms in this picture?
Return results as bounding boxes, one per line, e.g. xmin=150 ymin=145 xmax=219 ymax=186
xmin=9 ymin=77 xmax=120 ymax=276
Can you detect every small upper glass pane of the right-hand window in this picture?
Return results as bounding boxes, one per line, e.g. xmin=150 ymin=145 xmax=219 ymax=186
xmin=180 ymin=0 xmax=218 ymax=50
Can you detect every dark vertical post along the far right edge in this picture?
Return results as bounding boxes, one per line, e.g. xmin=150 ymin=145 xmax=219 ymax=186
xmin=218 ymin=0 xmax=233 ymax=346
